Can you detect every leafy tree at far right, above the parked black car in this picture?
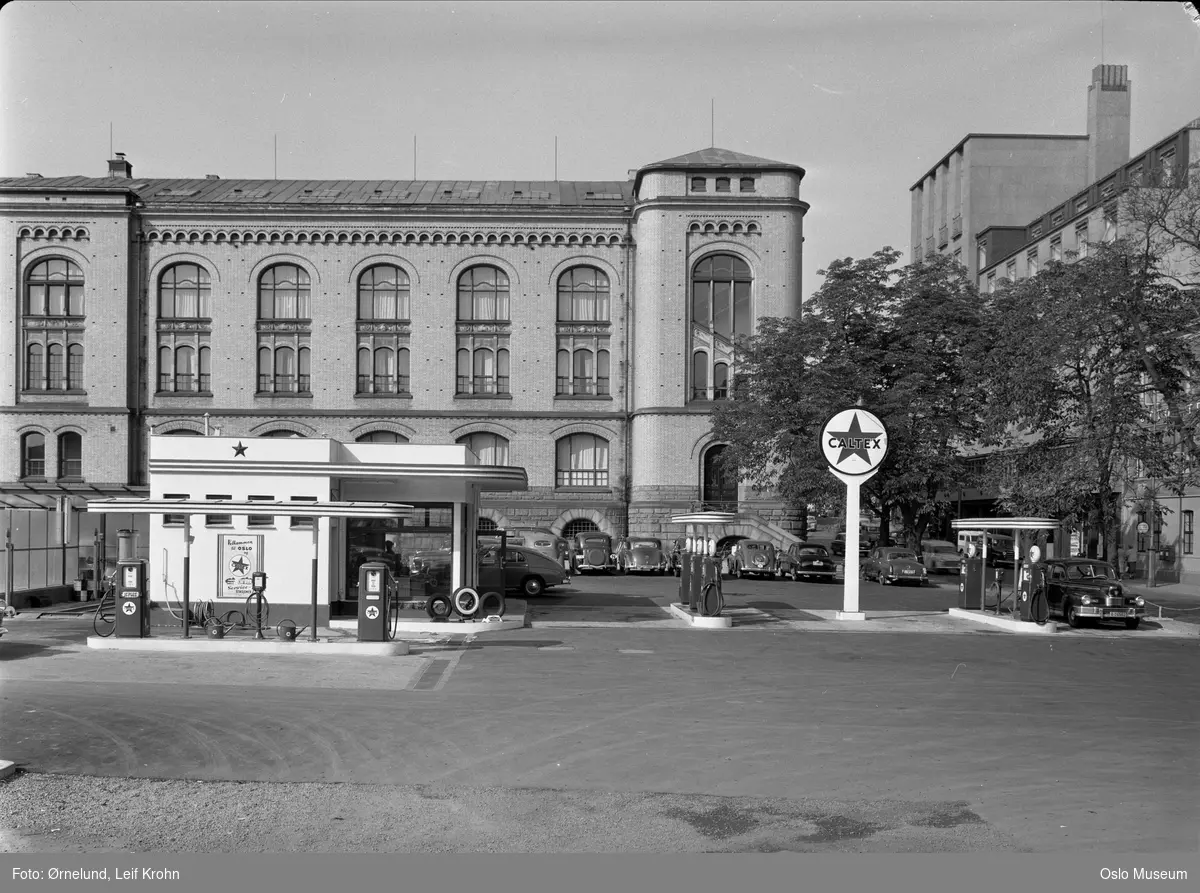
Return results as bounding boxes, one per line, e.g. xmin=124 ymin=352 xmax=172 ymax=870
xmin=980 ymin=241 xmax=1200 ymax=553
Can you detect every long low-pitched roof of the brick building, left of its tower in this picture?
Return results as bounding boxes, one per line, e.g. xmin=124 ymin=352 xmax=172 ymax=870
xmin=0 ymin=176 xmax=634 ymax=208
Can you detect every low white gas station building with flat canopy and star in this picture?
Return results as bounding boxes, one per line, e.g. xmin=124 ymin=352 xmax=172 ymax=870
xmin=90 ymin=436 xmax=528 ymax=625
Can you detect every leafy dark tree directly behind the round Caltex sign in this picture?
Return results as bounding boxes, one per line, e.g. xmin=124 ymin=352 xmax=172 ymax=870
xmin=713 ymin=247 xmax=983 ymax=547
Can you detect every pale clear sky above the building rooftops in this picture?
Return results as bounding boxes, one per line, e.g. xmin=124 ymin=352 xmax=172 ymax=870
xmin=0 ymin=0 xmax=1200 ymax=298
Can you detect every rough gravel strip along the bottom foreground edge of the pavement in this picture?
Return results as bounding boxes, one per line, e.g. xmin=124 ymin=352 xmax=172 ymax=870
xmin=0 ymin=772 xmax=1016 ymax=853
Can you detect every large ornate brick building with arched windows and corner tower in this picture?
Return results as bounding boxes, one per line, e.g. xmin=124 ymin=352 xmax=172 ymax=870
xmin=0 ymin=149 xmax=808 ymax=602
